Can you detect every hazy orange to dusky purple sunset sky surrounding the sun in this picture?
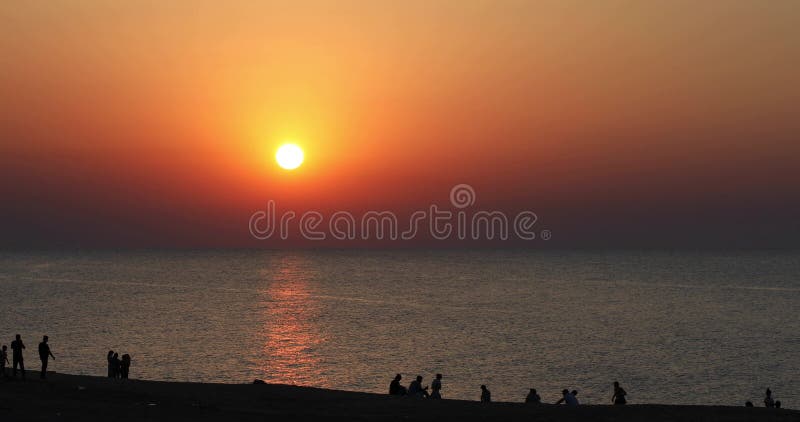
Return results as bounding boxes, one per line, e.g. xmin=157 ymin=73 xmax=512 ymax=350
xmin=0 ymin=0 xmax=800 ymax=249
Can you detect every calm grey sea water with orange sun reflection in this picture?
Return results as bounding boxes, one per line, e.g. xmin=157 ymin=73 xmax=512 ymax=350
xmin=0 ymin=251 xmax=800 ymax=408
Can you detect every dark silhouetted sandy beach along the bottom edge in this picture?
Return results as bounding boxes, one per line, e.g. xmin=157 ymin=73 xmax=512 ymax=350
xmin=0 ymin=371 xmax=800 ymax=421
